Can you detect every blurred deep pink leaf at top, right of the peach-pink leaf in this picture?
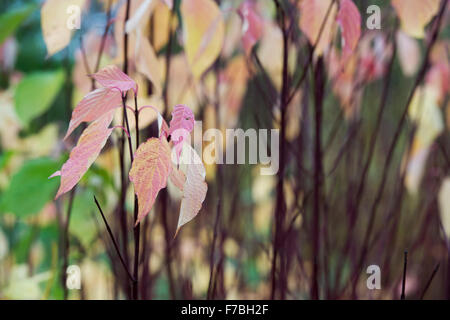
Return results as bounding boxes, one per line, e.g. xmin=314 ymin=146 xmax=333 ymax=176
xmin=337 ymin=0 xmax=361 ymax=58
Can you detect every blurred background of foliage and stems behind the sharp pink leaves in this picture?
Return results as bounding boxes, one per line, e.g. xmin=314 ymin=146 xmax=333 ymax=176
xmin=0 ymin=0 xmax=450 ymax=299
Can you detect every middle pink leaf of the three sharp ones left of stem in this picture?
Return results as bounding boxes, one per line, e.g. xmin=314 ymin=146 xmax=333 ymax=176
xmin=64 ymin=88 xmax=122 ymax=139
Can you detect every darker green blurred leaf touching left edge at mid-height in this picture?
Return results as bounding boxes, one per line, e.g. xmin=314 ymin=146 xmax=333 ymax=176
xmin=0 ymin=158 xmax=61 ymax=217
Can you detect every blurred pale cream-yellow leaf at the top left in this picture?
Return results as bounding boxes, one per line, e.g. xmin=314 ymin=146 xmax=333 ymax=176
xmin=41 ymin=0 xmax=85 ymax=56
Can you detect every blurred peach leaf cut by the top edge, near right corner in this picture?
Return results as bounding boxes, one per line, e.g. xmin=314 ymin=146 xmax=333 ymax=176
xmin=391 ymin=0 xmax=440 ymax=38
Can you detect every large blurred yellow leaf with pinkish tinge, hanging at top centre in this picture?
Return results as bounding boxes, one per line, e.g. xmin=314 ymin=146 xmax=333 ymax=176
xmin=181 ymin=0 xmax=225 ymax=79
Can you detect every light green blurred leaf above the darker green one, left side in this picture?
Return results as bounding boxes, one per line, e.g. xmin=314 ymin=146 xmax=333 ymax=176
xmin=14 ymin=70 xmax=64 ymax=125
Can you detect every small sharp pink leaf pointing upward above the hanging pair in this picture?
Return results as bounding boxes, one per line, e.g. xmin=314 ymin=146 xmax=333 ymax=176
xmin=169 ymin=104 xmax=194 ymax=159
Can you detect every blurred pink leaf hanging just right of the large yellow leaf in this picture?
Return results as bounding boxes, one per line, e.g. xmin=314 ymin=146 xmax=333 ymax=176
xmin=238 ymin=0 xmax=263 ymax=54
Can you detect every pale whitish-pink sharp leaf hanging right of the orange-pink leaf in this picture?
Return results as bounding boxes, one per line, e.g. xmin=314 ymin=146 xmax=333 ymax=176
xmin=175 ymin=143 xmax=208 ymax=236
